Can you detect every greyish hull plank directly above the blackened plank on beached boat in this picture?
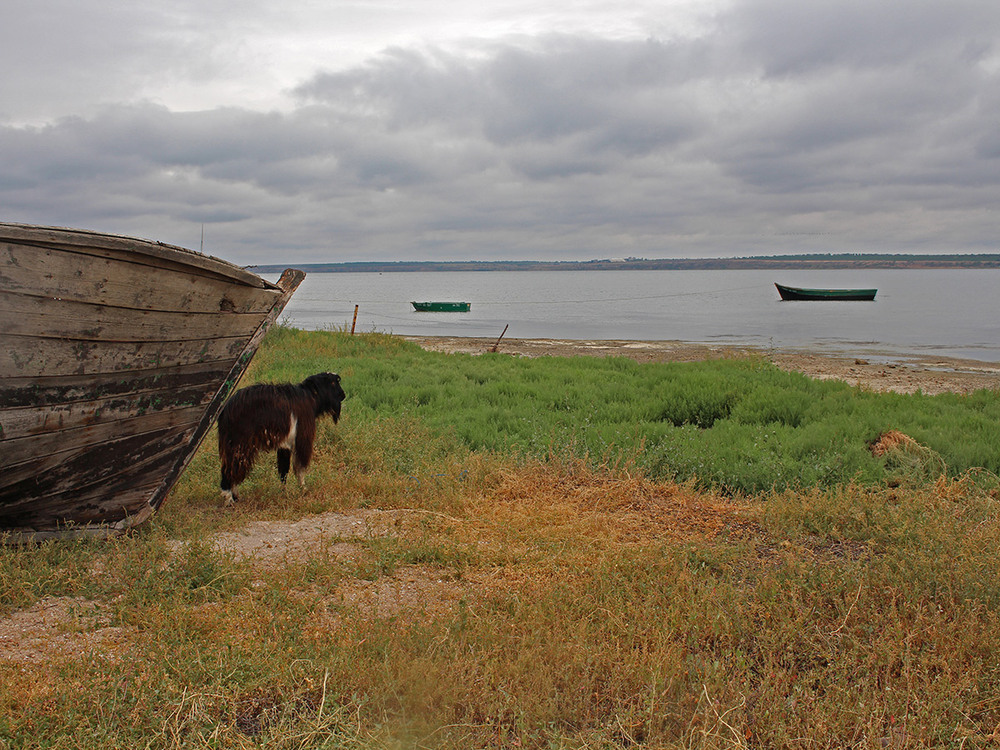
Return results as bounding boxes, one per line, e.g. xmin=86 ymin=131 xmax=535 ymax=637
xmin=0 ymin=336 xmax=247 ymax=382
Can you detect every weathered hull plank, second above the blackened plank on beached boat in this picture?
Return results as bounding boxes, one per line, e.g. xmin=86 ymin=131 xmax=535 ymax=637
xmin=0 ymin=291 xmax=260 ymax=341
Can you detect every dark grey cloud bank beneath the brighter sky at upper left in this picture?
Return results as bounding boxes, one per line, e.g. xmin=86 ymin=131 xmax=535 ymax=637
xmin=0 ymin=0 xmax=1000 ymax=263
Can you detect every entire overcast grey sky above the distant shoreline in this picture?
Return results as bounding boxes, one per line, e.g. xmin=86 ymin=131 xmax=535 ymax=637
xmin=0 ymin=0 xmax=1000 ymax=264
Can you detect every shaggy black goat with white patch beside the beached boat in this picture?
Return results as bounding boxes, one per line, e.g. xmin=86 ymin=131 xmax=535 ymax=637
xmin=219 ymin=372 xmax=345 ymax=505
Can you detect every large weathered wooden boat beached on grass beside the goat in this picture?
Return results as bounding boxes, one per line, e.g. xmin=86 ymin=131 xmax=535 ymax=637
xmin=0 ymin=224 xmax=305 ymax=540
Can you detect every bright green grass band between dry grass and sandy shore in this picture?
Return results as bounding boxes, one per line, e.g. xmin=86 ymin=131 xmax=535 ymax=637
xmin=232 ymin=328 xmax=1000 ymax=493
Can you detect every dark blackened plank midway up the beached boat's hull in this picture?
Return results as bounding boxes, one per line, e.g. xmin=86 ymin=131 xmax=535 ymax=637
xmin=0 ymin=360 xmax=232 ymax=408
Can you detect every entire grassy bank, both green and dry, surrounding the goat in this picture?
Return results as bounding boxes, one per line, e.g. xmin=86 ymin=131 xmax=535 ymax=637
xmin=0 ymin=329 xmax=1000 ymax=748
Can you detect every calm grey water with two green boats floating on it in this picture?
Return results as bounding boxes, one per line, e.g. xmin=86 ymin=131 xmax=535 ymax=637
xmin=270 ymin=270 xmax=1000 ymax=362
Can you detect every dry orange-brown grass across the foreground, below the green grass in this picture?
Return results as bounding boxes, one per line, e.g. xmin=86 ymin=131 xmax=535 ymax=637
xmin=0 ymin=462 xmax=1000 ymax=750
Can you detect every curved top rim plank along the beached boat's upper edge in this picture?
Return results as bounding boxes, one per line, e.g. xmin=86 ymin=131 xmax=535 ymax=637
xmin=0 ymin=223 xmax=274 ymax=289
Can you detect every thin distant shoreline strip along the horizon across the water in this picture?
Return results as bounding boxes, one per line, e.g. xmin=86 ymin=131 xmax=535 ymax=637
xmin=254 ymin=253 xmax=1000 ymax=273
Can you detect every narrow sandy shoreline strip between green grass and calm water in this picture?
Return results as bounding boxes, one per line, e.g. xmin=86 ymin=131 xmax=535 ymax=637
xmin=401 ymin=336 xmax=1000 ymax=394
